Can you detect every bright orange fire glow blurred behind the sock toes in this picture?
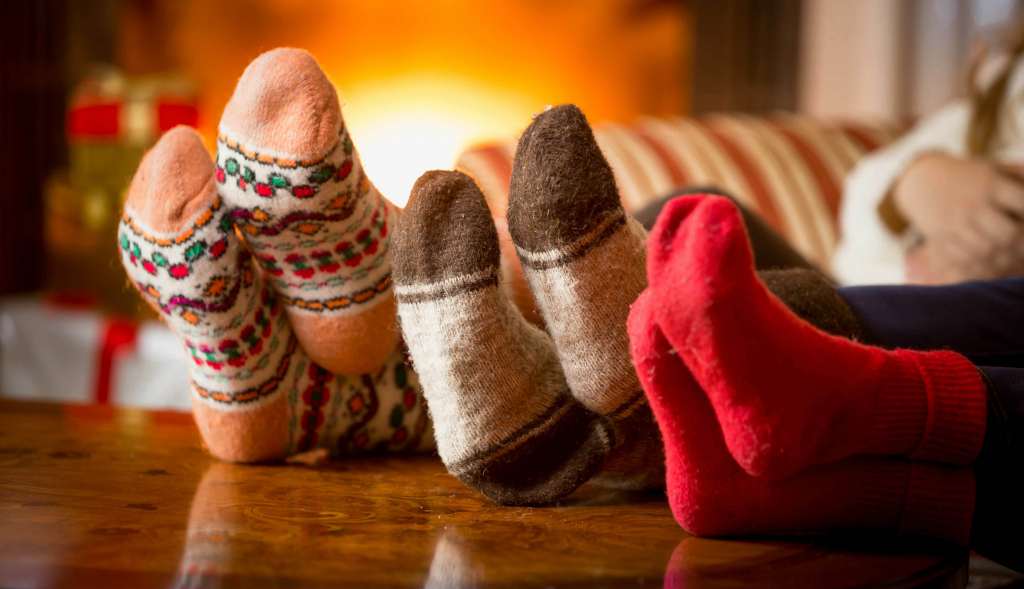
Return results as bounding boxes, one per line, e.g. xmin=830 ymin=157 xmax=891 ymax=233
xmin=165 ymin=0 xmax=688 ymax=205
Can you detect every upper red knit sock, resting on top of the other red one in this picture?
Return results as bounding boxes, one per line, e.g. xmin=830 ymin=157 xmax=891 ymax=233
xmin=647 ymin=196 xmax=985 ymax=477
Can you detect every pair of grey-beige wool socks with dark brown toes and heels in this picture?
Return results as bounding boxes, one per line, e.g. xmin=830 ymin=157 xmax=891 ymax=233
xmin=393 ymin=106 xmax=663 ymax=504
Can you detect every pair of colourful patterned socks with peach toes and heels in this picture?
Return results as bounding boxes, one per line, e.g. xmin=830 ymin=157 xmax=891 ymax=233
xmin=119 ymin=49 xmax=433 ymax=462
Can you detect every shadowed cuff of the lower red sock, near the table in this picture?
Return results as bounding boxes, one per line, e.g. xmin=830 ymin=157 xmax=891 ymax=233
xmin=897 ymin=463 xmax=975 ymax=546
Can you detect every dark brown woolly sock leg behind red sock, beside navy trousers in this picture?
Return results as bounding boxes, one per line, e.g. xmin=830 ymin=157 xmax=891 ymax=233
xmin=759 ymin=268 xmax=865 ymax=341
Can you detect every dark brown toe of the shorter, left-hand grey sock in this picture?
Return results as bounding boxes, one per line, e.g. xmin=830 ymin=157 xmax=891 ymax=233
xmin=392 ymin=171 xmax=501 ymax=285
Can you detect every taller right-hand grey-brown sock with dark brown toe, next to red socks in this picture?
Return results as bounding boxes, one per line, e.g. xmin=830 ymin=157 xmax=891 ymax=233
xmin=508 ymin=106 xmax=664 ymax=488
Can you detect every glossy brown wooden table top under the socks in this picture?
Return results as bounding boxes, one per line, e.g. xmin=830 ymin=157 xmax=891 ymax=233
xmin=0 ymin=401 xmax=967 ymax=587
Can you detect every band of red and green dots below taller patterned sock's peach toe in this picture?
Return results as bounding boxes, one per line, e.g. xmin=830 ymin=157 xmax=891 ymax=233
xmin=215 ymin=139 xmax=353 ymax=199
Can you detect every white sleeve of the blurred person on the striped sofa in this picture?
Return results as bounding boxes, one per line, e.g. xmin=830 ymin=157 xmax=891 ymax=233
xmin=831 ymin=100 xmax=971 ymax=285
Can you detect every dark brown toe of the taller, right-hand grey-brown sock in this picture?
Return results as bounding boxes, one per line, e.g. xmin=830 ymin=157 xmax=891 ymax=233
xmin=508 ymin=104 xmax=622 ymax=251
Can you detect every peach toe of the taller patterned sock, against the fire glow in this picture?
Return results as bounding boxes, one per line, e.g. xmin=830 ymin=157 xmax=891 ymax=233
xmin=220 ymin=47 xmax=342 ymax=160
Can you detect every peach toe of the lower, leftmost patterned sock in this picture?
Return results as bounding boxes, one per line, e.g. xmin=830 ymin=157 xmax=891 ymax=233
xmin=126 ymin=127 xmax=217 ymax=232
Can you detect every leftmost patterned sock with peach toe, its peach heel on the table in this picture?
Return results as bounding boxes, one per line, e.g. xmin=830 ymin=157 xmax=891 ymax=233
xmin=118 ymin=127 xmax=432 ymax=462
